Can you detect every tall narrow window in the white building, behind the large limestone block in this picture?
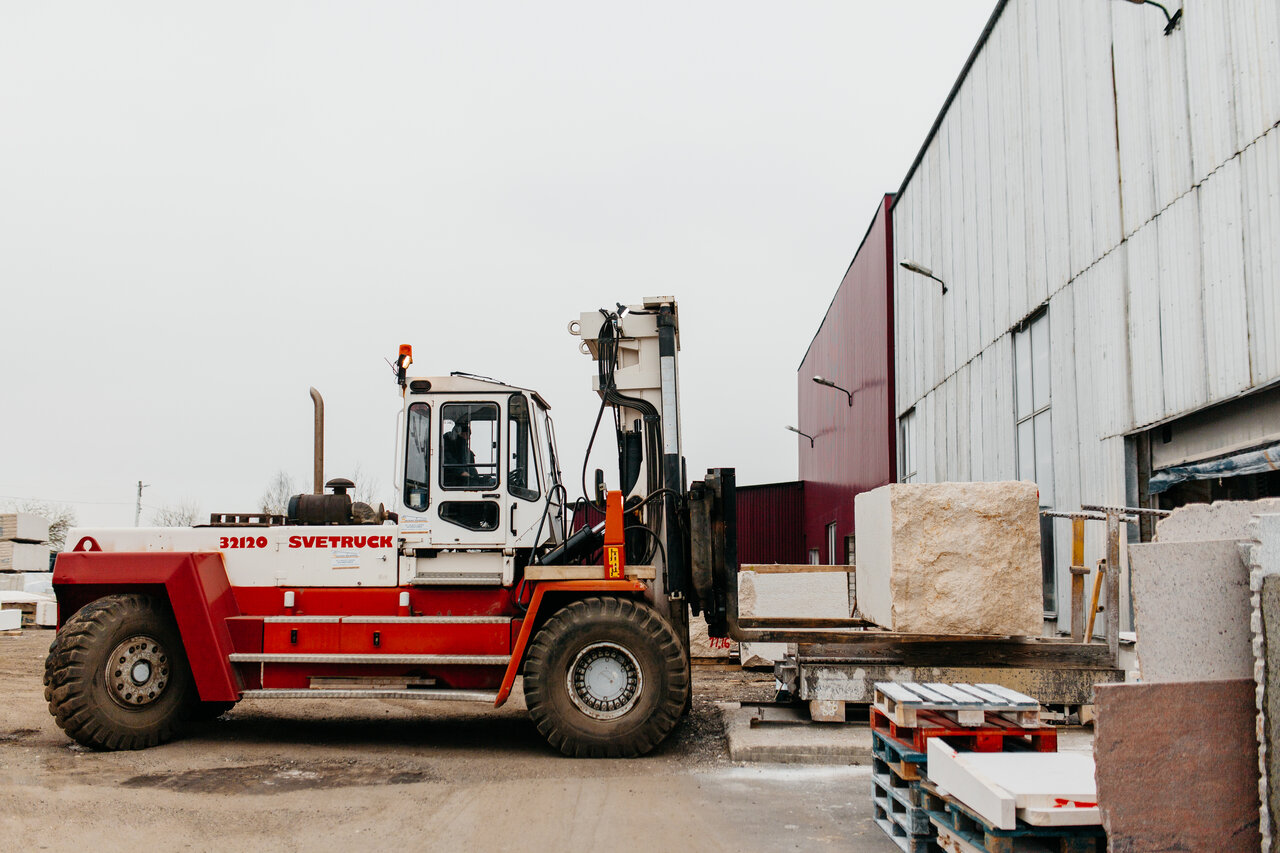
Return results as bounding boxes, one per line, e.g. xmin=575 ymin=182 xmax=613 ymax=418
xmin=1014 ymin=311 xmax=1057 ymax=613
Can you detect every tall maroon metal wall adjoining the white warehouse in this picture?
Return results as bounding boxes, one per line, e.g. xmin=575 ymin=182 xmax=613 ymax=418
xmin=796 ymin=195 xmax=897 ymax=564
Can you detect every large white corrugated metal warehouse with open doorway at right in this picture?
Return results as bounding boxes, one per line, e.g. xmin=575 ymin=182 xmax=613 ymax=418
xmin=892 ymin=0 xmax=1280 ymax=628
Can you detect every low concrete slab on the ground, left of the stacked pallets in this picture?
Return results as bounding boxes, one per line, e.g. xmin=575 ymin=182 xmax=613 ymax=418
xmin=719 ymin=702 xmax=872 ymax=765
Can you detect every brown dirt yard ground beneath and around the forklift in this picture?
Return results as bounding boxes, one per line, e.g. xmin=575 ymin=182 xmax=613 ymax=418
xmin=0 ymin=630 xmax=897 ymax=853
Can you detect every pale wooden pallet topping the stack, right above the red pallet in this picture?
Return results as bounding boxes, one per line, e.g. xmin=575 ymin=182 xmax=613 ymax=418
xmin=873 ymin=681 xmax=1039 ymax=727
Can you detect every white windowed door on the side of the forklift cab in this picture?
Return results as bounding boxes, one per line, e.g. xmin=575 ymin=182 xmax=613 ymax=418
xmin=431 ymin=398 xmax=509 ymax=548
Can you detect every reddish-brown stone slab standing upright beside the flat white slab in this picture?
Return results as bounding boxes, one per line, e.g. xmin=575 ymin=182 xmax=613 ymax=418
xmin=1093 ymin=679 xmax=1262 ymax=853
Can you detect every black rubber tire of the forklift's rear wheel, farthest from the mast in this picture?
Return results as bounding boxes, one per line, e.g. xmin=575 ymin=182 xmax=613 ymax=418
xmin=45 ymin=594 xmax=196 ymax=749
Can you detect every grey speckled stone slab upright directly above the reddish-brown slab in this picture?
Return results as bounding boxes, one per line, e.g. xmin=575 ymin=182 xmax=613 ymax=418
xmin=1129 ymin=539 xmax=1253 ymax=681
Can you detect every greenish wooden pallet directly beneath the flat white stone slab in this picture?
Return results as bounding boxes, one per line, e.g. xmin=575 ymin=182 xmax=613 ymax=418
xmin=922 ymin=783 xmax=1107 ymax=853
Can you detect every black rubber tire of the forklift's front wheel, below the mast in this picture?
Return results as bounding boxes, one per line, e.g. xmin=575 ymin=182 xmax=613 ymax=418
xmin=524 ymin=598 xmax=689 ymax=758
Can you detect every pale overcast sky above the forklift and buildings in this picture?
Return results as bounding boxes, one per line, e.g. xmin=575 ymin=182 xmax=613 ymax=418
xmin=0 ymin=0 xmax=995 ymax=525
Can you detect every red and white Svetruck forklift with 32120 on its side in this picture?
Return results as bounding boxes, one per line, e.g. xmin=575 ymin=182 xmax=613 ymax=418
xmin=45 ymin=297 xmax=747 ymax=756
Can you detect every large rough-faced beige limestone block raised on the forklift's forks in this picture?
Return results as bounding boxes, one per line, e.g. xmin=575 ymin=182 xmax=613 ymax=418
xmin=854 ymin=482 xmax=1043 ymax=637
